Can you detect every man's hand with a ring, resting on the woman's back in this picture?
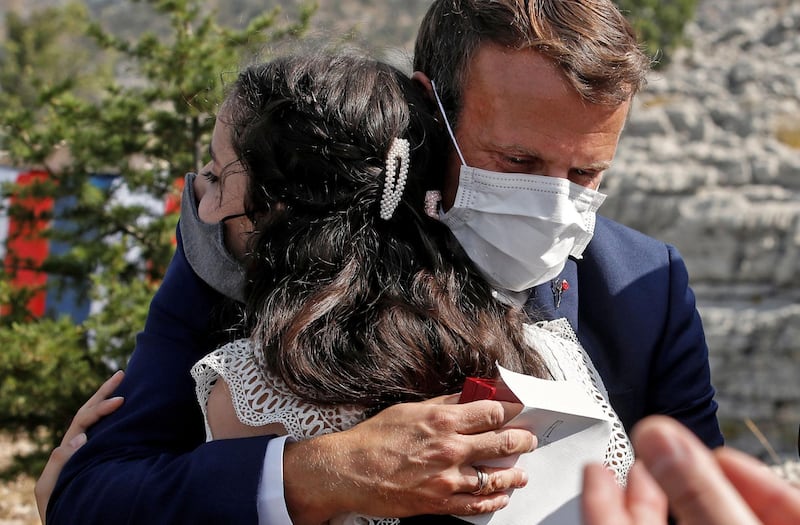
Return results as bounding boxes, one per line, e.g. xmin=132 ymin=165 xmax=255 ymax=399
xmin=284 ymin=396 xmax=536 ymax=524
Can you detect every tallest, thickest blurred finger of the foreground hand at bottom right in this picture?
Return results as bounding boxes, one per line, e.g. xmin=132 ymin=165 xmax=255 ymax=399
xmin=632 ymin=416 xmax=759 ymax=525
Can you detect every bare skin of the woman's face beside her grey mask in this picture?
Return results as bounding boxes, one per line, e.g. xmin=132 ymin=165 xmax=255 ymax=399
xmin=194 ymin=116 xmax=252 ymax=259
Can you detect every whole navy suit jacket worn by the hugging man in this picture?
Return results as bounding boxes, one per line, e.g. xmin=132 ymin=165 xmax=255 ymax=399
xmin=47 ymin=218 xmax=722 ymax=525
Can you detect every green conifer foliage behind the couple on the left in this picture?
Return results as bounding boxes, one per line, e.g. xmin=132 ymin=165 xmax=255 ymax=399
xmin=0 ymin=0 xmax=315 ymax=474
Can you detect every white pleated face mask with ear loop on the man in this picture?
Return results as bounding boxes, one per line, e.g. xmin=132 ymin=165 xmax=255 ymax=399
xmin=433 ymin=79 xmax=606 ymax=292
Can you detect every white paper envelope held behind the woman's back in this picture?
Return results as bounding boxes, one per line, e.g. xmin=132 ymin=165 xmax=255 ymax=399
xmin=459 ymin=367 xmax=612 ymax=525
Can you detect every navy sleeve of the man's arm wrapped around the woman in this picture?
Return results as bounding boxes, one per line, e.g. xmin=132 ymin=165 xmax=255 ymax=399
xmin=47 ymin=231 xmax=270 ymax=525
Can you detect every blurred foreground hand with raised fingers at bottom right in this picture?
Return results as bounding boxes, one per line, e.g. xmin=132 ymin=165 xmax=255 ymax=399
xmin=583 ymin=416 xmax=800 ymax=525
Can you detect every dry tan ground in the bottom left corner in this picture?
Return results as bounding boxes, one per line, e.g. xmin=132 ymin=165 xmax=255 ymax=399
xmin=0 ymin=435 xmax=40 ymax=525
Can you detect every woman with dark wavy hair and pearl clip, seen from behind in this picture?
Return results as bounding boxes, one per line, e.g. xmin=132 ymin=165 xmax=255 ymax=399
xmin=189 ymin=55 xmax=627 ymax=522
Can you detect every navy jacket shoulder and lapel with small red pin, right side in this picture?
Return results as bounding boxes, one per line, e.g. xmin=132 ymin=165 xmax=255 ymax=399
xmin=526 ymin=217 xmax=723 ymax=447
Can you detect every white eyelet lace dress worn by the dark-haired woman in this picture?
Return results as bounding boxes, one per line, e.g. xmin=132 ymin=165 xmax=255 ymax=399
xmin=192 ymin=319 xmax=633 ymax=525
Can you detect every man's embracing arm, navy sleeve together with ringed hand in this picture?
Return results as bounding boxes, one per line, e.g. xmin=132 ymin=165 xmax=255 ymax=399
xmin=47 ymin=229 xmax=535 ymax=525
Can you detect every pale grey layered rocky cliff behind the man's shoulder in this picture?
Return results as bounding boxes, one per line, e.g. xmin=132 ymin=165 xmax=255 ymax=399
xmin=602 ymin=0 xmax=800 ymax=457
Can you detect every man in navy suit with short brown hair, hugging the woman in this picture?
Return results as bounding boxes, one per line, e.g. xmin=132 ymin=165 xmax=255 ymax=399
xmin=43 ymin=0 xmax=722 ymax=524
